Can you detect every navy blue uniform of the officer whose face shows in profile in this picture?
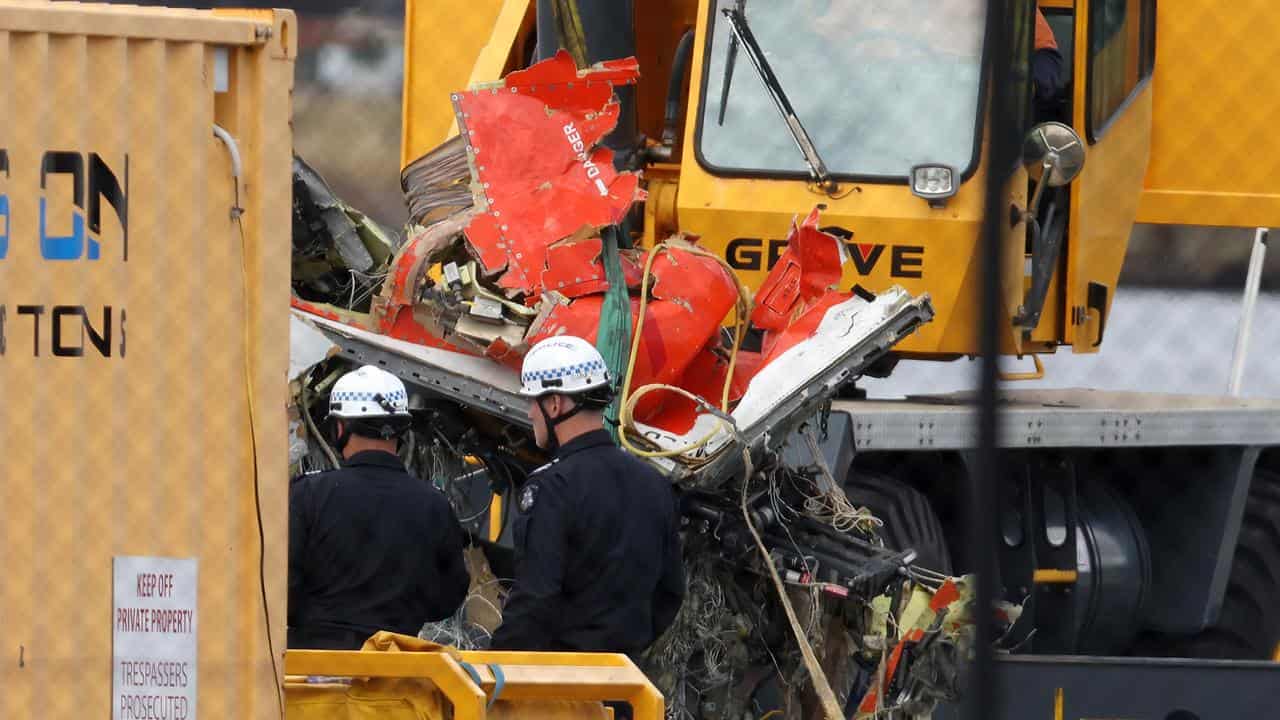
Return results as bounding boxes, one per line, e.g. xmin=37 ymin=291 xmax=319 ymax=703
xmin=492 ymin=430 xmax=685 ymax=653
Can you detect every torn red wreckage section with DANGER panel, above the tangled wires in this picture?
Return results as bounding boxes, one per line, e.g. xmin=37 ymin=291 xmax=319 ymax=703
xmin=294 ymin=53 xmax=932 ymax=466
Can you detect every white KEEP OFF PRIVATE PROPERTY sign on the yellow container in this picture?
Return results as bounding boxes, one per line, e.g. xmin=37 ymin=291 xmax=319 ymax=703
xmin=111 ymin=557 xmax=197 ymax=720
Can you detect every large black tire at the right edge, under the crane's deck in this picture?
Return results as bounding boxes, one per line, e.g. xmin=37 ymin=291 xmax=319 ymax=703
xmin=1143 ymin=469 xmax=1280 ymax=660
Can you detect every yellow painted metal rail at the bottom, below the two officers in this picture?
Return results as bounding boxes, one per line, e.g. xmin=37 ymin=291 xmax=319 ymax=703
xmin=284 ymin=650 xmax=664 ymax=720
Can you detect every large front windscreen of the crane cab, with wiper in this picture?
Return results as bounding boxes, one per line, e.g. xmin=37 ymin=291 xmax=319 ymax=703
xmin=698 ymin=0 xmax=987 ymax=182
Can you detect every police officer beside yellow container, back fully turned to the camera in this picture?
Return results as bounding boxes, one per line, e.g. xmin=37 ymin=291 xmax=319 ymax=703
xmin=288 ymin=365 xmax=470 ymax=650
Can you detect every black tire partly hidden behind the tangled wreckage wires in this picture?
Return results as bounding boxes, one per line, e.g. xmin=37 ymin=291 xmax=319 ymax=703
xmin=845 ymin=470 xmax=951 ymax=574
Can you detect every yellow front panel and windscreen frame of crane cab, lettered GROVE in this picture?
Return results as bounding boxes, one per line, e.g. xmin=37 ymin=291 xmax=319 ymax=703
xmin=677 ymin=0 xmax=1034 ymax=356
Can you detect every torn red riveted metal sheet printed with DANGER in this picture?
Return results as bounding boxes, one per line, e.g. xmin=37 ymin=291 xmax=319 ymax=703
xmin=453 ymin=51 xmax=643 ymax=292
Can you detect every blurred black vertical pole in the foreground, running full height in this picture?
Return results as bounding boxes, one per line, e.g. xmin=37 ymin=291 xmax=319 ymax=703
xmin=965 ymin=0 xmax=1030 ymax=720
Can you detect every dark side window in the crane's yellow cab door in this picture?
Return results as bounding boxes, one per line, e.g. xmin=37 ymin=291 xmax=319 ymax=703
xmin=1088 ymin=0 xmax=1156 ymax=140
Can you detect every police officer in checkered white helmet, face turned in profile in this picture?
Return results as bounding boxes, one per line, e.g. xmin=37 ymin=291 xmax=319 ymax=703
xmin=492 ymin=336 xmax=685 ymax=653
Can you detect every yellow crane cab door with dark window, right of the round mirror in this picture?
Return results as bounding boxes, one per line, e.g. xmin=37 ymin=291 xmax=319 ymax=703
xmin=1062 ymin=0 xmax=1164 ymax=352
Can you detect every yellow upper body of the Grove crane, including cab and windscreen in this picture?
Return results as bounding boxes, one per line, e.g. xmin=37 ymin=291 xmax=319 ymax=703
xmin=403 ymin=0 xmax=1280 ymax=359
